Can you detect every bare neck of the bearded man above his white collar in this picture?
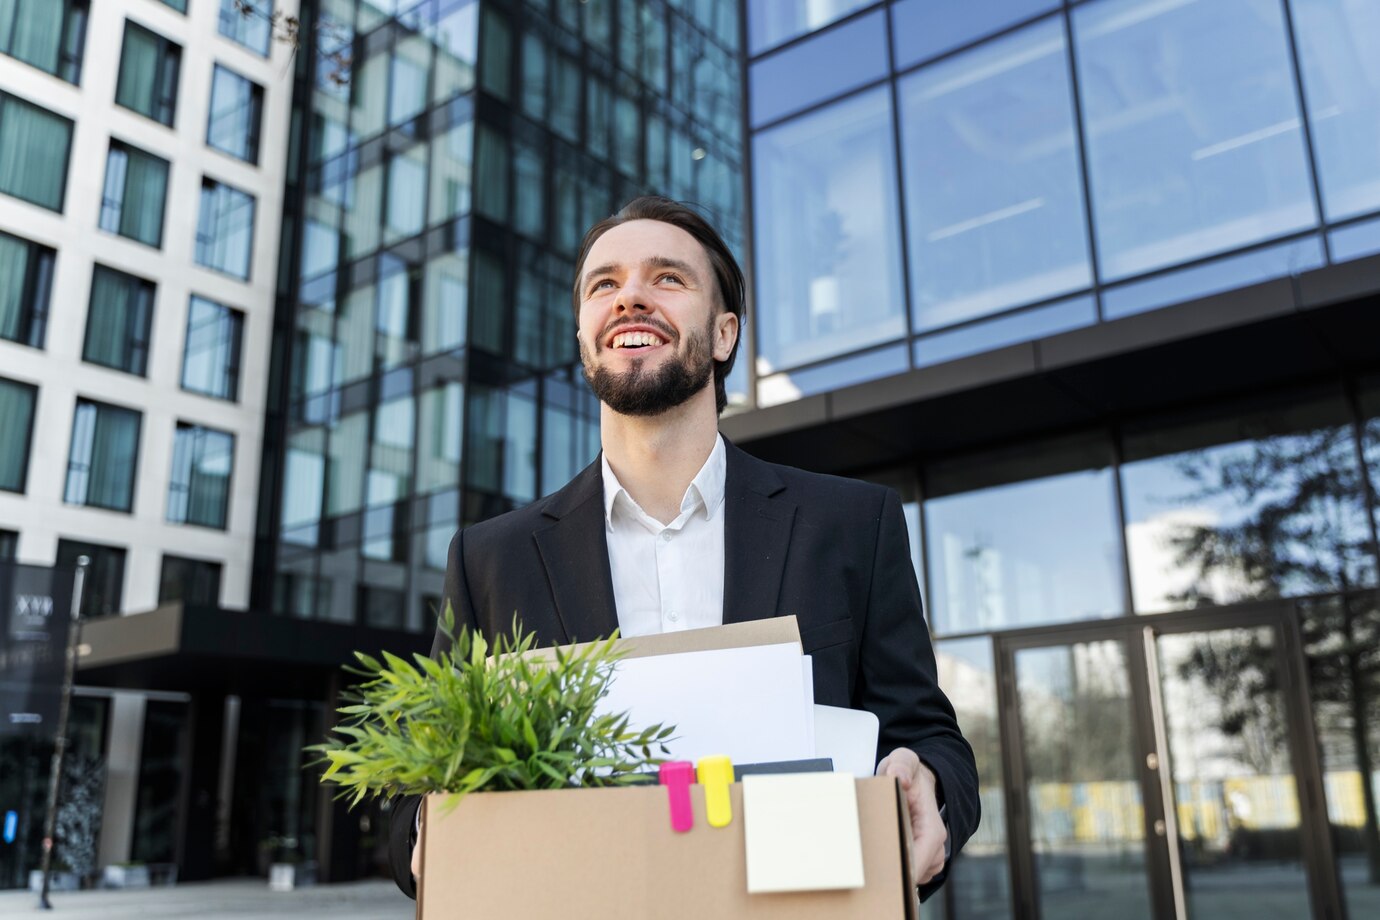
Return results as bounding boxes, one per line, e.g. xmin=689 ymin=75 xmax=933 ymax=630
xmin=599 ymin=386 xmax=719 ymax=524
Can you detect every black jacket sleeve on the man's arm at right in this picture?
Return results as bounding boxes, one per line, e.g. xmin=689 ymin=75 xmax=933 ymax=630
xmin=854 ymin=488 xmax=981 ymax=899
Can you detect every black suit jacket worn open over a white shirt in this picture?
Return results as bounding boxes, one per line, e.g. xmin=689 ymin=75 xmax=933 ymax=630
xmin=391 ymin=443 xmax=978 ymax=897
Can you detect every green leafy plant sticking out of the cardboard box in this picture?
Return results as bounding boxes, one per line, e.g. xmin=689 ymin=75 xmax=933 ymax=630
xmin=311 ymin=604 xmax=673 ymax=807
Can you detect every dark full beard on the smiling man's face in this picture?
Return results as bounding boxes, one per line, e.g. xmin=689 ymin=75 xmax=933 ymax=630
xmin=580 ymin=314 xmax=713 ymax=415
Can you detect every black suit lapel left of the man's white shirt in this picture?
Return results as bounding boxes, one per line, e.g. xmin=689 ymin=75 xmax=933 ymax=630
xmin=533 ymin=459 xmax=618 ymax=644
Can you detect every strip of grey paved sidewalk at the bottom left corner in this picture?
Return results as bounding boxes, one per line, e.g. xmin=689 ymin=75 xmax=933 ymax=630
xmin=0 ymin=879 xmax=414 ymax=920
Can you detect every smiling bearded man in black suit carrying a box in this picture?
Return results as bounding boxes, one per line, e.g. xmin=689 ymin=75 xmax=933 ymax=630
xmin=392 ymin=197 xmax=978 ymax=897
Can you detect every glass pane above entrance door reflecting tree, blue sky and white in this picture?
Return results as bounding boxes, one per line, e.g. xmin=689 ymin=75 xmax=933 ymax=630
xmin=1122 ymin=403 xmax=1376 ymax=614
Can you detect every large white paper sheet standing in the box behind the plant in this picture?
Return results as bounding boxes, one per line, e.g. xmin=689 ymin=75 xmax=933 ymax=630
xmin=599 ymin=644 xmax=814 ymax=764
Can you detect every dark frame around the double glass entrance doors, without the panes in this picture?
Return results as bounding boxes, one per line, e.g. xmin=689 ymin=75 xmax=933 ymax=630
xmin=992 ymin=600 xmax=1346 ymax=920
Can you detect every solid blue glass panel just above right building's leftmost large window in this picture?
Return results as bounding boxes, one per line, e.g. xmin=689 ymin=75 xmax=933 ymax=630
xmin=748 ymin=10 xmax=886 ymax=126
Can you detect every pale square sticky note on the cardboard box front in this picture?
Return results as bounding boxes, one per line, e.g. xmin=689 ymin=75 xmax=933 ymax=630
xmin=742 ymin=772 xmax=864 ymax=894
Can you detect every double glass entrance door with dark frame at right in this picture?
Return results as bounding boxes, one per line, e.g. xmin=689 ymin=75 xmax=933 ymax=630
xmin=998 ymin=608 xmax=1334 ymax=920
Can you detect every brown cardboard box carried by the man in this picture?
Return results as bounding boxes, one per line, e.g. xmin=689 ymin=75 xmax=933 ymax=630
xmin=417 ymin=777 xmax=918 ymax=920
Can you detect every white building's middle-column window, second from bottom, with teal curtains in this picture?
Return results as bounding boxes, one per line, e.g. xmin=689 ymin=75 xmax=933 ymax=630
xmin=63 ymin=399 xmax=141 ymax=512
